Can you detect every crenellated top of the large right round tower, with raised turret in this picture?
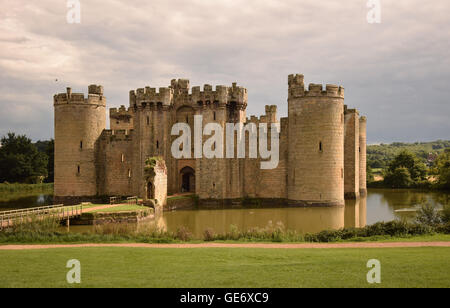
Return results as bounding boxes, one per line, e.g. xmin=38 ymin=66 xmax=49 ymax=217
xmin=288 ymin=74 xmax=344 ymax=98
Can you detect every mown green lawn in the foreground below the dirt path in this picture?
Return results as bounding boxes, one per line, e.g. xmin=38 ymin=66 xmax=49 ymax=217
xmin=0 ymin=248 xmax=450 ymax=288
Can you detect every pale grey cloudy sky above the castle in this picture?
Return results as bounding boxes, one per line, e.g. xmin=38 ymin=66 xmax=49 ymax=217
xmin=0 ymin=0 xmax=450 ymax=143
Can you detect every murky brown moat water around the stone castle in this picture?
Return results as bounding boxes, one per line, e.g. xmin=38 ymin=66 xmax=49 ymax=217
xmin=0 ymin=189 xmax=450 ymax=236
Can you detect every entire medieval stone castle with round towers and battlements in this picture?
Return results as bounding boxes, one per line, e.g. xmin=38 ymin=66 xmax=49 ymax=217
xmin=54 ymin=75 xmax=366 ymax=206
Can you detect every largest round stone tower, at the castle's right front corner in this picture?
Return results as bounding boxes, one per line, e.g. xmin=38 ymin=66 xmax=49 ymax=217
xmin=288 ymin=75 xmax=344 ymax=205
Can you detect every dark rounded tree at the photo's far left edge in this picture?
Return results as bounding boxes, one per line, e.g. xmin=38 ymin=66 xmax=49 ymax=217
xmin=0 ymin=133 xmax=48 ymax=183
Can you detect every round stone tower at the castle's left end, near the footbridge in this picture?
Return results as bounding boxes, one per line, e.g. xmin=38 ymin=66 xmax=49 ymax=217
xmin=54 ymin=85 xmax=106 ymax=203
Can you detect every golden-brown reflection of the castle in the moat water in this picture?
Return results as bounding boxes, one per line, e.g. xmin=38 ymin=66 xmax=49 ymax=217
xmin=155 ymin=198 xmax=367 ymax=237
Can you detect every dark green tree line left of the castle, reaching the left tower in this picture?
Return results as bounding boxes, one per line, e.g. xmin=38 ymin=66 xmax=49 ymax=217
xmin=0 ymin=133 xmax=54 ymax=184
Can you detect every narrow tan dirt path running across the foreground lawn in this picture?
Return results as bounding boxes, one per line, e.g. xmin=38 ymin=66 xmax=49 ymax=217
xmin=0 ymin=242 xmax=450 ymax=250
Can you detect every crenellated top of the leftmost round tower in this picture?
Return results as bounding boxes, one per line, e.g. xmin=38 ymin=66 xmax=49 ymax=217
xmin=53 ymin=85 xmax=106 ymax=106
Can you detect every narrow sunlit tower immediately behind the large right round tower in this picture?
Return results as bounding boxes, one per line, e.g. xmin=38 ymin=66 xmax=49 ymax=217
xmin=344 ymin=108 xmax=359 ymax=199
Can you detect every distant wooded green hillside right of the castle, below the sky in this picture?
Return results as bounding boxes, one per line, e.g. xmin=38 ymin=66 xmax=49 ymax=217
xmin=367 ymin=140 xmax=450 ymax=169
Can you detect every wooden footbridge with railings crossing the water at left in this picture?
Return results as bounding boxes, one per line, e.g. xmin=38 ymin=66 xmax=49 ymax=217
xmin=0 ymin=204 xmax=83 ymax=229
